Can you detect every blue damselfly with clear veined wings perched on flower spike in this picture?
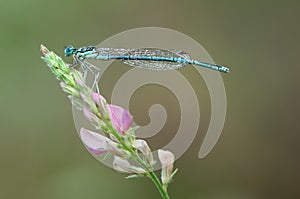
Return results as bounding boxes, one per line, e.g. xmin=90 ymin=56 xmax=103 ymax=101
xmin=65 ymin=46 xmax=229 ymax=73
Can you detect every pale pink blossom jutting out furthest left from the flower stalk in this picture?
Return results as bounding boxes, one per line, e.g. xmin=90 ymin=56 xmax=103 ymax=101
xmin=80 ymin=128 xmax=125 ymax=157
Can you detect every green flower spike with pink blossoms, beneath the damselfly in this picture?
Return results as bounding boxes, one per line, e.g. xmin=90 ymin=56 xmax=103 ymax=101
xmin=41 ymin=45 xmax=177 ymax=199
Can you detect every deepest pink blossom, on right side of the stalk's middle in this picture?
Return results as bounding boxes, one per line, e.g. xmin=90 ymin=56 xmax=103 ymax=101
xmin=106 ymin=104 xmax=132 ymax=135
